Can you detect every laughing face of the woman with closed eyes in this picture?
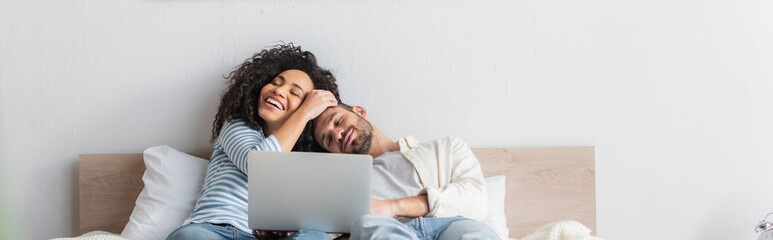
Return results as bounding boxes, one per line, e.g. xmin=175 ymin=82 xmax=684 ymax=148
xmin=258 ymin=69 xmax=314 ymax=125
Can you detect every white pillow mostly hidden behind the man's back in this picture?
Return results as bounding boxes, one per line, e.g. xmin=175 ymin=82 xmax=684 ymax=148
xmin=486 ymin=175 xmax=510 ymax=239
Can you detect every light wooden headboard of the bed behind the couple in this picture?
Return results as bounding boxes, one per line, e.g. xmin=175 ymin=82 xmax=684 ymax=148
xmin=78 ymin=147 xmax=597 ymax=238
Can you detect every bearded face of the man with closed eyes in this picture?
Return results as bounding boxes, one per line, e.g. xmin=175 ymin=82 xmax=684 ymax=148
xmin=314 ymin=106 xmax=373 ymax=154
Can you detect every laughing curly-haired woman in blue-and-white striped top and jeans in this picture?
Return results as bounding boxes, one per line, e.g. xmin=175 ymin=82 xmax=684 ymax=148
xmin=167 ymin=44 xmax=338 ymax=240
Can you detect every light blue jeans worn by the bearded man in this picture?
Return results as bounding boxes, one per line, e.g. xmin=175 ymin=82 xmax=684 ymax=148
xmin=352 ymin=215 xmax=499 ymax=240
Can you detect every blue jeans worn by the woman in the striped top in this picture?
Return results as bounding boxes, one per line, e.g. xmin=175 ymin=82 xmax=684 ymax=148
xmin=166 ymin=223 xmax=331 ymax=240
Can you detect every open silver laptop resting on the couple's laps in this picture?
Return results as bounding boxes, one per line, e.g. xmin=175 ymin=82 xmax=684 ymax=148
xmin=247 ymin=151 xmax=373 ymax=233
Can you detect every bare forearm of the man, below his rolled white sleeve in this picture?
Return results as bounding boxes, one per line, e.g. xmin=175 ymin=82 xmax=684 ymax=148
xmin=370 ymin=195 xmax=429 ymax=217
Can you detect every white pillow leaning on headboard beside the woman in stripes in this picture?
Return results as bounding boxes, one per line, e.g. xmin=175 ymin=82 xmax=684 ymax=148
xmin=121 ymin=146 xmax=209 ymax=240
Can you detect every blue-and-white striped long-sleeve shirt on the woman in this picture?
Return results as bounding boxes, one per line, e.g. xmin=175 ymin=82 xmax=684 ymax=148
xmin=185 ymin=119 xmax=282 ymax=233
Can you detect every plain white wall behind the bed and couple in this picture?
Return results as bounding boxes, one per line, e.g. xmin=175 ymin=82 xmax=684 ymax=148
xmin=0 ymin=0 xmax=773 ymax=240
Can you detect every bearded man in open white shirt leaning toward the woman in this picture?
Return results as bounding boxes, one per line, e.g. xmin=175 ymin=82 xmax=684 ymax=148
xmin=314 ymin=104 xmax=499 ymax=239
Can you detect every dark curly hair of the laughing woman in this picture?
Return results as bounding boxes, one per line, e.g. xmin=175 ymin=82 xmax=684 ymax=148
xmin=211 ymin=43 xmax=340 ymax=151
